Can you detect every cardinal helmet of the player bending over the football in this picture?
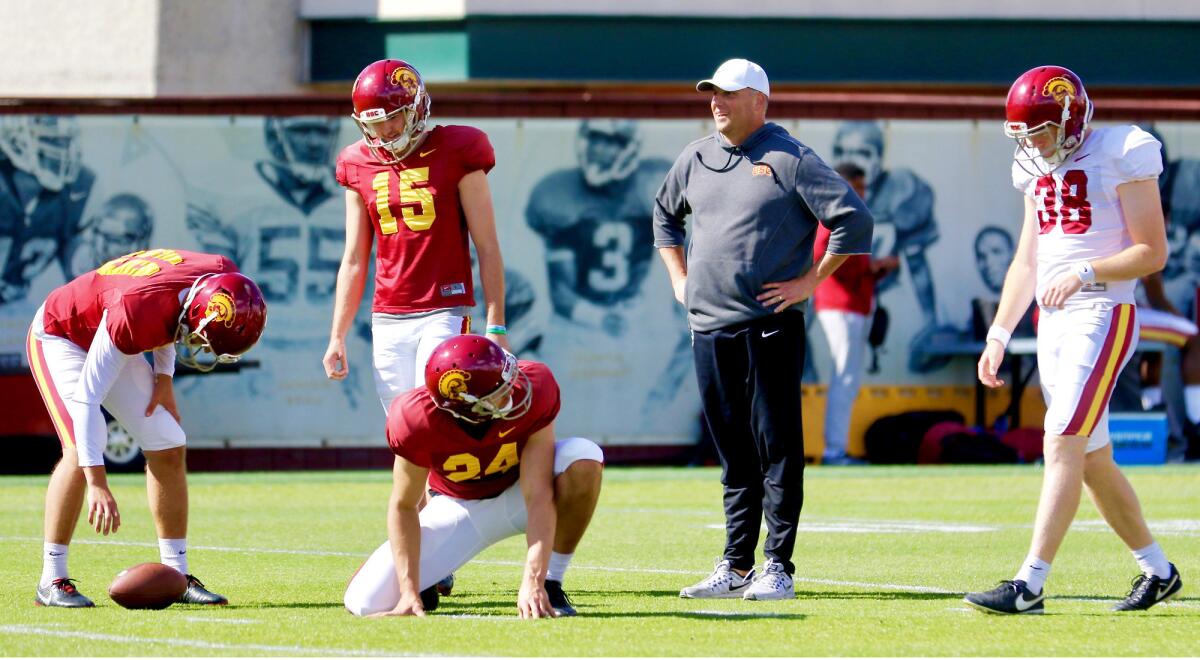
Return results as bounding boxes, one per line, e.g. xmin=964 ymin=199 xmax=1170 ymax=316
xmin=175 ymin=272 xmax=266 ymax=371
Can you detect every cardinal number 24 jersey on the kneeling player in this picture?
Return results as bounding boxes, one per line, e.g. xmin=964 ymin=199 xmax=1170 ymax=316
xmin=388 ymin=360 xmax=559 ymax=499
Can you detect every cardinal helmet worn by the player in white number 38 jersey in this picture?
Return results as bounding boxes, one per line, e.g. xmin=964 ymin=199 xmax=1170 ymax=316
xmin=1004 ymin=66 xmax=1092 ymax=176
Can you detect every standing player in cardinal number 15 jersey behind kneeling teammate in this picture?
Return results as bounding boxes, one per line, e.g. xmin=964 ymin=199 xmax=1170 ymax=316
xmin=323 ymin=60 xmax=508 ymax=410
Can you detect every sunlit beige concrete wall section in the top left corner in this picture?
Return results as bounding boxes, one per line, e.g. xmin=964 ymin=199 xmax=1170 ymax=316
xmin=0 ymin=0 xmax=158 ymax=97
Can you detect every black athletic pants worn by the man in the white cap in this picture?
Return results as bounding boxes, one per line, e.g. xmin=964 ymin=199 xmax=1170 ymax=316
xmin=692 ymin=312 xmax=805 ymax=575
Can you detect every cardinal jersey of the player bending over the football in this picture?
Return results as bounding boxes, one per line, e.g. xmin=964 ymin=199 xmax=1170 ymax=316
xmin=42 ymin=250 xmax=238 ymax=355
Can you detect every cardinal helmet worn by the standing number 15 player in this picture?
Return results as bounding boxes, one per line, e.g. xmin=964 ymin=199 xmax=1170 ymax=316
xmin=350 ymin=60 xmax=430 ymax=164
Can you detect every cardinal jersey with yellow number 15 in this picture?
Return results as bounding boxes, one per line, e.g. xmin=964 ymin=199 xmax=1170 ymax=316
xmin=337 ymin=126 xmax=496 ymax=314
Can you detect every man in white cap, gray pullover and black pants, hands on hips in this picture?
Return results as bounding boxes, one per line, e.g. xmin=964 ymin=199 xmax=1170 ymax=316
xmin=654 ymin=59 xmax=874 ymax=600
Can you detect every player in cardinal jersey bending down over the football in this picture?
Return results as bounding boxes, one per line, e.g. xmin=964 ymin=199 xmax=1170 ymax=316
xmin=28 ymin=250 xmax=266 ymax=607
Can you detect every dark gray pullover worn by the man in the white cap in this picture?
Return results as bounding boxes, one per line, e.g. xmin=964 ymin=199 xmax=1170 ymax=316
xmin=654 ymin=122 xmax=875 ymax=332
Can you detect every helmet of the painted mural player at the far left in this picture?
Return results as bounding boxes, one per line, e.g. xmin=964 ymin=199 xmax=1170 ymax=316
xmin=0 ymin=115 xmax=82 ymax=191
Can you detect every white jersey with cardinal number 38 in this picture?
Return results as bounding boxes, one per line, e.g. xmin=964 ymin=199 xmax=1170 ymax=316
xmin=1013 ymin=126 xmax=1163 ymax=307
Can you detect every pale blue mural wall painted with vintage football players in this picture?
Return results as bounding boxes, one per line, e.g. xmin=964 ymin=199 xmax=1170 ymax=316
xmin=0 ymin=115 xmax=1200 ymax=446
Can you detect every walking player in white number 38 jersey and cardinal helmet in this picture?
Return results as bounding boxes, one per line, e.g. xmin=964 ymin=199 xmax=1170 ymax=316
xmin=965 ymin=66 xmax=1183 ymax=614
